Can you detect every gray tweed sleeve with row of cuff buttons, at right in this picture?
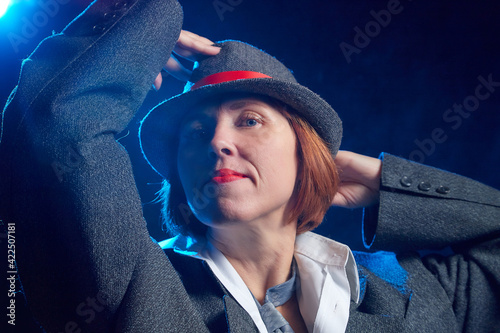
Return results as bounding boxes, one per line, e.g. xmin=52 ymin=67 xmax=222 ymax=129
xmin=363 ymin=154 xmax=500 ymax=252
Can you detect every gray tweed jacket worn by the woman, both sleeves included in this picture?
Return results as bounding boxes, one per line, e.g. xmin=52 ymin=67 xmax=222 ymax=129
xmin=0 ymin=0 xmax=500 ymax=332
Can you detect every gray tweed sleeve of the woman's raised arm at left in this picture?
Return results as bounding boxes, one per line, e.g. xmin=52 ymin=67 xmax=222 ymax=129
xmin=0 ymin=0 xmax=205 ymax=332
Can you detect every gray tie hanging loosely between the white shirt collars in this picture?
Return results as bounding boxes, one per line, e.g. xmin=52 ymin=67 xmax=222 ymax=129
xmin=255 ymin=262 xmax=295 ymax=333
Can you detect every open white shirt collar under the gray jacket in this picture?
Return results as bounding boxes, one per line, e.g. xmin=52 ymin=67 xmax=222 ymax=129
xmin=160 ymin=232 xmax=359 ymax=333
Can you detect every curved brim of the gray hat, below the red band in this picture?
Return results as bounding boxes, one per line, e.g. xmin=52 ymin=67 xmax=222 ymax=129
xmin=139 ymin=78 xmax=342 ymax=180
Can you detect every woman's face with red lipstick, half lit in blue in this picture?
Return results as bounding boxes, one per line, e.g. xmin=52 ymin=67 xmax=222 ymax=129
xmin=177 ymin=97 xmax=298 ymax=227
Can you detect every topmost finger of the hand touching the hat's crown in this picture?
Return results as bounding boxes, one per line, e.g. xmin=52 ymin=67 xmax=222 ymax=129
xmin=174 ymin=30 xmax=220 ymax=61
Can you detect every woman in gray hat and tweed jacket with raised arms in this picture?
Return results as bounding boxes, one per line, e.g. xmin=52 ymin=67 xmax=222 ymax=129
xmin=0 ymin=1 xmax=500 ymax=332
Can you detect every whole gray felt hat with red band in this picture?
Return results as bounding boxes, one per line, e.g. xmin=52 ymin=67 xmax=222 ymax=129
xmin=139 ymin=41 xmax=342 ymax=180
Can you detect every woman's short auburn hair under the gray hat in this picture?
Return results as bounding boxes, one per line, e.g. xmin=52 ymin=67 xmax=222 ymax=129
xmin=158 ymin=94 xmax=339 ymax=235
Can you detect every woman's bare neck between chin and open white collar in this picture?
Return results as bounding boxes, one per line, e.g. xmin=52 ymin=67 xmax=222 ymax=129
xmin=208 ymin=218 xmax=297 ymax=303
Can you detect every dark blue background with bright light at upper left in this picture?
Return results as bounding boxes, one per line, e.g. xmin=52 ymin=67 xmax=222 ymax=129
xmin=0 ymin=0 xmax=500 ymax=331
